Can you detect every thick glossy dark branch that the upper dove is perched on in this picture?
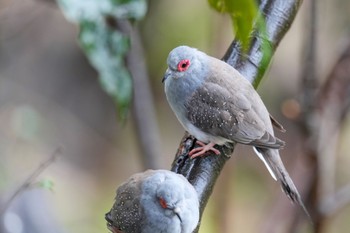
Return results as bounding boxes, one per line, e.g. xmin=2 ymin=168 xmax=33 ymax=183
xmin=171 ymin=0 xmax=301 ymax=231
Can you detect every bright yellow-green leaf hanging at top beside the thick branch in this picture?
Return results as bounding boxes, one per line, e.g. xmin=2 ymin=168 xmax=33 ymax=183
xmin=208 ymin=0 xmax=258 ymax=51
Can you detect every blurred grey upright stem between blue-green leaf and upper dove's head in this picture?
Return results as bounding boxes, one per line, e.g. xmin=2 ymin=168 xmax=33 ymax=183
xmin=118 ymin=20 xmax=162 ymax=169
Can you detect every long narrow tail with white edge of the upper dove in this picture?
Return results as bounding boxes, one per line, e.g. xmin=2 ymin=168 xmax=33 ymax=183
xmin=254 ymin=147 xmax=311 ymax=220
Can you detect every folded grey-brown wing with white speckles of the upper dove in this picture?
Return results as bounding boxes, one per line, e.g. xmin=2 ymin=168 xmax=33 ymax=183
xmin=186 ymin=80 xmax=284 ymax=149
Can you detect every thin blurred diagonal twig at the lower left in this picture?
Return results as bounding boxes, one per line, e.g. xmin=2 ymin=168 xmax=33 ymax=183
xmin=0 ymin=146 xmax=62 ymax=216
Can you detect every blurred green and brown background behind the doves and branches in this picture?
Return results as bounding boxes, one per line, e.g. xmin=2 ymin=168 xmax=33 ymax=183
xmin=0 ymin=0 xmax=350 ymax=233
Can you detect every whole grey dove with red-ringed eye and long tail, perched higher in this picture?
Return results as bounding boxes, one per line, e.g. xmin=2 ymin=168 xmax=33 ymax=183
xmin=162 ymin=46 xmax=308 ymax=215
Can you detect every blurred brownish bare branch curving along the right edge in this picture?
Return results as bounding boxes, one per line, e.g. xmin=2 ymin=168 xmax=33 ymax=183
xmin=317 ymin=40 xmax=350 ymax=222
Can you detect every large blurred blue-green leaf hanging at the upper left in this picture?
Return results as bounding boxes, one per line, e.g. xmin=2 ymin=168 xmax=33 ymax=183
xmin=58 ymin=0 xmax=147 ymax=120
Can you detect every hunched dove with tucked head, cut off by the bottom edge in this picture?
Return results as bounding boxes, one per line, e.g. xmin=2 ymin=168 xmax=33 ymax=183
xmin=106 ymin=170 xmax=199 ymax=233
